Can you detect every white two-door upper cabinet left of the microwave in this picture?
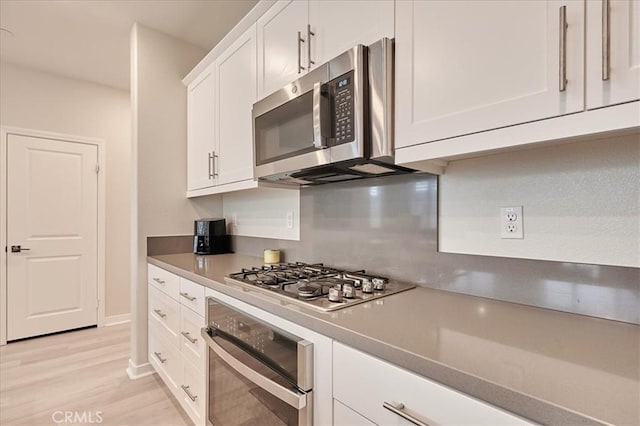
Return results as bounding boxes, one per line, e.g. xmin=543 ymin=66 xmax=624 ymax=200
xmin=187 ymin=25 xmax=258 ymax=197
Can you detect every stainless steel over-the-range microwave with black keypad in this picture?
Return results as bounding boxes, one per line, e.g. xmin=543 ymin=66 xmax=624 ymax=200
xmin=252 ymin=38 xmax=413 ymax=185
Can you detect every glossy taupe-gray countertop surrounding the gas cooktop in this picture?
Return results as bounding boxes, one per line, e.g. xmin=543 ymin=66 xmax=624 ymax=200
xmin=148 ymin=253 xmax=640 ymax=425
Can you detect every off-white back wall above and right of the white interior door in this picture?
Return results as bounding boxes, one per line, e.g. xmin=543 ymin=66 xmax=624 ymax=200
xmin=0 ymin=63 xmax=131 ymax=317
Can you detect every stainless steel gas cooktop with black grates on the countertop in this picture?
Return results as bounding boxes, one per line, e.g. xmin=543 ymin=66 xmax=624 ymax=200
xmin=225 ymin=262 xmax=415 ymax=312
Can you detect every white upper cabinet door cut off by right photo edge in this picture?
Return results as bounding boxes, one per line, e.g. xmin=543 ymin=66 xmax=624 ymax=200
xmin=587 ymin=0 xmax=640 ymax=109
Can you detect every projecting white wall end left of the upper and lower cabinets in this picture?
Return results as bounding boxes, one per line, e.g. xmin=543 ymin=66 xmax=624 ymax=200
xmin=128 ymin=24 xmax=222 ymax=377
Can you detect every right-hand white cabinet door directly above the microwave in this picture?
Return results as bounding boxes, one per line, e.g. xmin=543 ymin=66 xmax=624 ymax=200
xmin=304 ymin=0 xmax=394 ymax=67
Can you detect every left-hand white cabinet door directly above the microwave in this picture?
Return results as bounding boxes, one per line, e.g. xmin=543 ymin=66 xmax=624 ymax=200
xmin=256 ymin=0 xmax=308 ymax=97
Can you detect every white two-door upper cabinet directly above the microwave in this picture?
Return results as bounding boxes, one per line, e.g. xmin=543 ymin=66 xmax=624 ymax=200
xmin=257 ymin=0 xmax=394 ymax=98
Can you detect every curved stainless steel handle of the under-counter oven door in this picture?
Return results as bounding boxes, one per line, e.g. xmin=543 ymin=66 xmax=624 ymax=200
xmin=200 ymin=328 xmax=307 ymax=410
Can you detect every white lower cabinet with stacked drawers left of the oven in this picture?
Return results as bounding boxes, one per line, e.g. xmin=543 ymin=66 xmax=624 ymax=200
xmin=148 ymin=265 xmax=206 ymax=425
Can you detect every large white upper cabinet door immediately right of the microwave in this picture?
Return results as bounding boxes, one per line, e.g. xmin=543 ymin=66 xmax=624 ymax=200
xmin=395 ymin=0 xmax=584 ymax=147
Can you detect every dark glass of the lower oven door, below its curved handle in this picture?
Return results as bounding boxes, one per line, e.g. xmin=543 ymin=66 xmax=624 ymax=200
xmin=209 ymin=349 xmax=298 ymax=426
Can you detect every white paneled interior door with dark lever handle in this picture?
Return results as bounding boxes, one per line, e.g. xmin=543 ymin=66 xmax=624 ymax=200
xmin=7 ymin=135 xmax=98 ymax=340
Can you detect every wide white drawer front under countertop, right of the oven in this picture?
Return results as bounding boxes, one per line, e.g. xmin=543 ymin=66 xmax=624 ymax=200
xmin=333 ymin=342 xmax=532 ymax=425
